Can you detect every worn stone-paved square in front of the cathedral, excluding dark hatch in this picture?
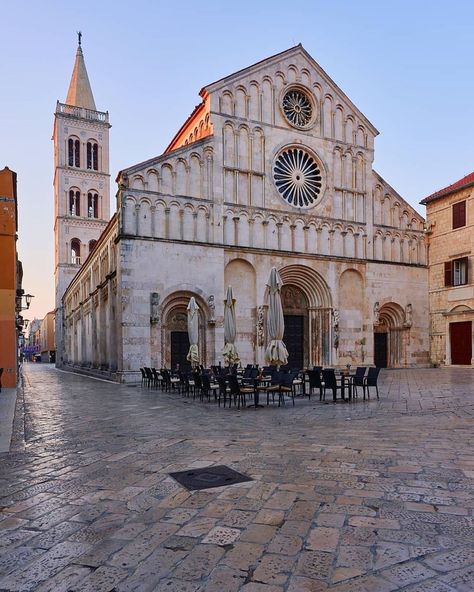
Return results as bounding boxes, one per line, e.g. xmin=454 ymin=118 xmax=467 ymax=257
xmin=0 ymin=364 xmax=474 ymax=592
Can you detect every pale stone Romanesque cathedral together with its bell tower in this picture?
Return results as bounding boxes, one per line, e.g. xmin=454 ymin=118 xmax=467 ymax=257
xmin=55 ymin=45 xmax=429 ymax=382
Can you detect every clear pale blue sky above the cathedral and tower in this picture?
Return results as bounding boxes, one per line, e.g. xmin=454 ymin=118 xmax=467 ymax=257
xmin=0 ymin=0 xmax=474 ymax=319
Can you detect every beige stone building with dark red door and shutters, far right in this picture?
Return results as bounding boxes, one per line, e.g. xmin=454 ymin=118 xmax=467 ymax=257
xmin=421 ymin=173 xmax=474 ymax=365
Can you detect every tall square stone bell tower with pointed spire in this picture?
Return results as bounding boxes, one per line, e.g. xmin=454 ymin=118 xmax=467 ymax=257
xmin=53 ymin=33 xmax=111 ymax=366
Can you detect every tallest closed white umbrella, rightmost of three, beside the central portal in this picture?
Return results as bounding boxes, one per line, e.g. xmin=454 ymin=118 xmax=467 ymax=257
xmin=265 ymin=267 xmax=288 ymax=366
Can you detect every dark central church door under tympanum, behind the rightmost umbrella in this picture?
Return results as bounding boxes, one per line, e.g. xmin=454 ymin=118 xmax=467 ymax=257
xmin=281 ymin=284 xmax=309 ymax=368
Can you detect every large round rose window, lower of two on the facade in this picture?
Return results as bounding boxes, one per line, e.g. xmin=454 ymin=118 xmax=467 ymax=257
xmin=273 ymin=147 xmax=323 ymax=208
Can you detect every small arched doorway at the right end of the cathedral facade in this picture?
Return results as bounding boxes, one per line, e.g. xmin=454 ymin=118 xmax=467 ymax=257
xmin=374 ymin=302 xmax=408 ymax=368
